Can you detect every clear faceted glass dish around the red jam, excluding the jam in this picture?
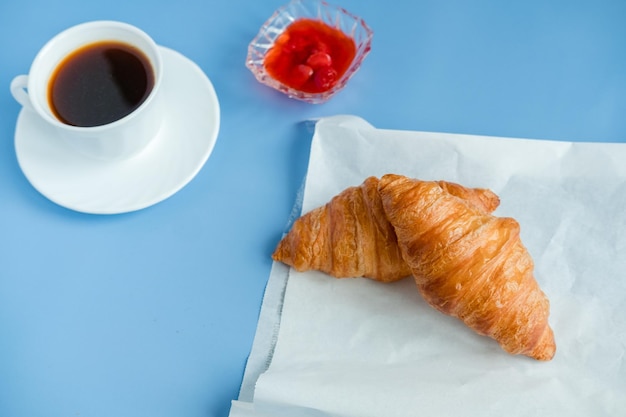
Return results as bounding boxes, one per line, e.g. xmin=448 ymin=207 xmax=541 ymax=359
xmin=246 ymin=0 xmax=374 ymax=104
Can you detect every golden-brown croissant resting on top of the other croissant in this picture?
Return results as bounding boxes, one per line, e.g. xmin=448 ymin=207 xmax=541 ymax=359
xmin=379 ymin=174 xmax=556 ymax=360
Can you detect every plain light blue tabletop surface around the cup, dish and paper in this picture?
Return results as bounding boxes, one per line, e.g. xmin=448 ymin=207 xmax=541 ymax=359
xmin=0 ymin=0 xmax=626 ymax=417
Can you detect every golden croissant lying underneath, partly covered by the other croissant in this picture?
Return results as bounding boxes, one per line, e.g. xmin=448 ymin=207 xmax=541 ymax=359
xmin=272 ymin=177 xmax=500 ymax=282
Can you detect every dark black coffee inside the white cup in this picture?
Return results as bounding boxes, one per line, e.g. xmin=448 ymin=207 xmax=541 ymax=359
xmin=48 ymin=41 xmax=154 ymax=127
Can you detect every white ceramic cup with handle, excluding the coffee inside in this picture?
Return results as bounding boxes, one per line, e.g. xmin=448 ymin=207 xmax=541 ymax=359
xmin=11 ymin=21 xmax=163 ymax=160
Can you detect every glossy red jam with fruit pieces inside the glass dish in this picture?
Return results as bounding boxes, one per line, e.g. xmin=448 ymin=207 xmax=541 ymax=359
xmin=263 ymin=19 xmax=356 ymax=93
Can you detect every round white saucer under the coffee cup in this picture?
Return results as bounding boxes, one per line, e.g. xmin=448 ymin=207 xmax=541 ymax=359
xmin=15 ymin=47 xmax=220 ymax=214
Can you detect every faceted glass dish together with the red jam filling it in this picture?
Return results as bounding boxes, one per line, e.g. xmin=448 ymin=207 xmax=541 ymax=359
xmin=246 ymin=0 xmax=373 ymax=103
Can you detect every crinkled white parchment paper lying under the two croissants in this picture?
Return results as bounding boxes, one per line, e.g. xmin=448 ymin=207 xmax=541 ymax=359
xmin=231 ymin=116 xmax=626 ymax=417
